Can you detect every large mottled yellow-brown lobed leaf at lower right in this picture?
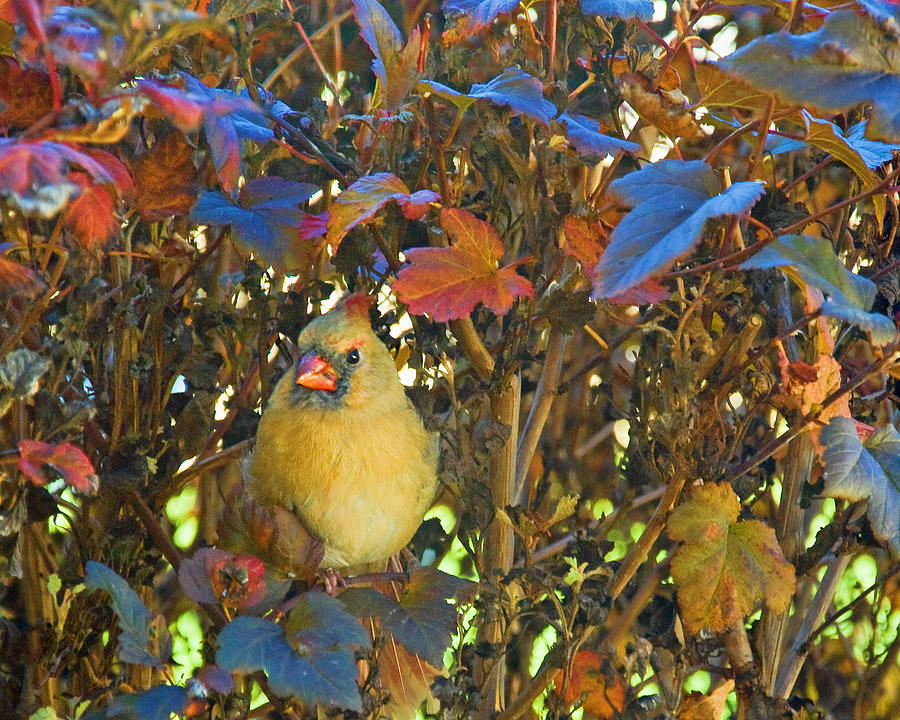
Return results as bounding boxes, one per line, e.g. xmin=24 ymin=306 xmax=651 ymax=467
xmin=668 ymin=483 xmax=794 ymax=633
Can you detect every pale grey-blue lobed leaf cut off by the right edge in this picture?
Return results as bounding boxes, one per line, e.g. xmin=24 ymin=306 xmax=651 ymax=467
xmin=820 ymin=417 xmax=900 ymax=556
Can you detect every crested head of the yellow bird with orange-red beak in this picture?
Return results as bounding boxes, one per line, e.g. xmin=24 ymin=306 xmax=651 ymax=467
xmin=289 ymin=293 xmax=397 ymax=409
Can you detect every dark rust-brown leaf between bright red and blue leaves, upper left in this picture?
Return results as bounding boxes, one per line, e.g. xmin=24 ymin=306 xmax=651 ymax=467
xmin=129 ymin=131 xmax=197 ymax=222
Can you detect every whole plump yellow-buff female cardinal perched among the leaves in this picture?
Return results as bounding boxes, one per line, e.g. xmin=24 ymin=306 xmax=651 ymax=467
xmin=245 ymin=294 xmax=438 ymax=568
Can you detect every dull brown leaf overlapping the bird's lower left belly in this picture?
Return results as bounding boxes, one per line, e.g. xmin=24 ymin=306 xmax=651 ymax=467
xmin=217 ymin=483 xmax=324 ymax=580
